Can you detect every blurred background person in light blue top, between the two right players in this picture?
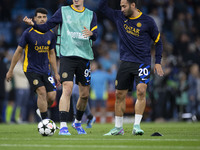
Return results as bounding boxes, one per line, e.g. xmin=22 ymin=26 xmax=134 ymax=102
xmin=90 ymin=61 xmax=116 ymax=123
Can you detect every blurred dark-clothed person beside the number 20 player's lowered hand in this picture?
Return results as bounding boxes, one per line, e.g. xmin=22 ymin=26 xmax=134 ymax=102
xmin=153 ymin=58 xmax=178 ymax=122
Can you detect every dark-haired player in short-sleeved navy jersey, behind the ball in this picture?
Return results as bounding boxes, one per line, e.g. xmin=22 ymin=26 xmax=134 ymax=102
xmin=6 ymin=8 xmax=60 ymax=119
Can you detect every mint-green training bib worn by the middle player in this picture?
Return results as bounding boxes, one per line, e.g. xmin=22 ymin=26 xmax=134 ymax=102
xmin=56 ymin=6 xmax=94 ymax=60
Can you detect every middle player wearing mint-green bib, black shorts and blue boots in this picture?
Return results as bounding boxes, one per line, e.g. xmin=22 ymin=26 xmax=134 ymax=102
xmin=24 ymin=0 xmax=97 ymax=135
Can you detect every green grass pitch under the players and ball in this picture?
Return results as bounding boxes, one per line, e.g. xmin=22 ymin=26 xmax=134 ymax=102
xmin=0 ymin=122 xmax=200 ymax=150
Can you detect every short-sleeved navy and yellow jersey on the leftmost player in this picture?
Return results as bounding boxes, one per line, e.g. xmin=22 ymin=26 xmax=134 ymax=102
xmin=19 ymin=27 xmax=56 ymax=74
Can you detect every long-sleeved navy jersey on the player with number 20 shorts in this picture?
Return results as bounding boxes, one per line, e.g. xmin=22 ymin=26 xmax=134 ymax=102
xmin=99 ymin=0 xmax=163 ymax=65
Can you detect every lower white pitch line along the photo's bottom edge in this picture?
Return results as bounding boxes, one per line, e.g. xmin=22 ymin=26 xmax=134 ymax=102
xmin=0 ymin=144 xmax=200 ymax=149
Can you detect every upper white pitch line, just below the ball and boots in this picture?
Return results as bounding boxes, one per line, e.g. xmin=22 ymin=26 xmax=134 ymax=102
xmin=0 ymin=137 xmax=200 ymax=142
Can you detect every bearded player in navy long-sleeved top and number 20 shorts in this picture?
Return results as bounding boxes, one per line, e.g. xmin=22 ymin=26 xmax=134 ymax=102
xmin=99 ymin=0 xmax=164 ymax=135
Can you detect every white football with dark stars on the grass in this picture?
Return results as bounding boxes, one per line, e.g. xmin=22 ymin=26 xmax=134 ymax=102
xmin=38 ymin=119 xmax=56 ymax=136
